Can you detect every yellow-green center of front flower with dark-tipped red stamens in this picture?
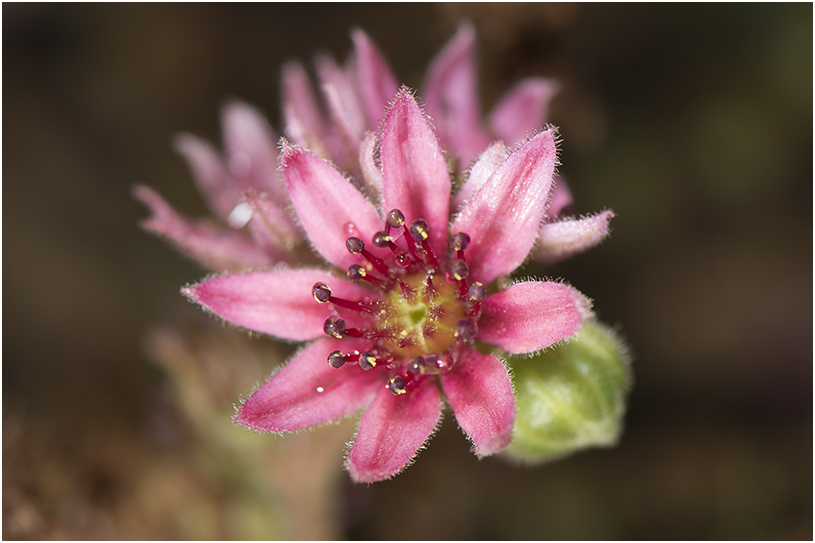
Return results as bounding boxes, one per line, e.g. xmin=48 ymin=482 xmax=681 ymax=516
xmin=312 ymin=209 xmax=486 ymax=395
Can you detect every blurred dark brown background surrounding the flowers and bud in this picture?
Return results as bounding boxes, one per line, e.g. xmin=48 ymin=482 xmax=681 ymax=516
xmin=3 ymin=3 xmax=813 ymax=540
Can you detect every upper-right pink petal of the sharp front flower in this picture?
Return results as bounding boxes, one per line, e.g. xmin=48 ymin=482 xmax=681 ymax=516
xmin=451 ymin=129 xmax=557 ymax=284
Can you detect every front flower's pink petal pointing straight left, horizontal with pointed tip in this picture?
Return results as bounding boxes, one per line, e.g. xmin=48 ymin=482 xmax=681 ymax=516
xmin=181 ymin=269 xmax=371 ymax=341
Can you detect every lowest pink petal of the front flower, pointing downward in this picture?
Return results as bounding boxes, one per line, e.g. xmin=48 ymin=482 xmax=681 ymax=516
xmin=345 ymin=378 xmax=441 ymax=483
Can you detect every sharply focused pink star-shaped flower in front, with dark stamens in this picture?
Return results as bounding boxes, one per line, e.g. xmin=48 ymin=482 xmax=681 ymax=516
xmin=183 ymin=88 xmax=591 ymax=482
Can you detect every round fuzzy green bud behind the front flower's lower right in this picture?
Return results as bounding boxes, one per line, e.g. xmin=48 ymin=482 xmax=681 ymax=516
xmin=503 ymin=322 xmax=631 ymax=462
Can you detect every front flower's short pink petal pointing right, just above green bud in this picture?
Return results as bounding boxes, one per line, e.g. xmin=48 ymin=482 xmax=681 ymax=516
xmin=477 ymin=281 xmax=591 ymax=354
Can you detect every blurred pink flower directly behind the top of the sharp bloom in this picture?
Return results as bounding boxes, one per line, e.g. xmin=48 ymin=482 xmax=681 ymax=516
xmin=282 ymin=24 xmax=614 ymax=263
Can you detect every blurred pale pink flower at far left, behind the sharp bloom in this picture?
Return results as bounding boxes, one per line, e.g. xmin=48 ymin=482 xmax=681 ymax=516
xmin=134 ymin=101 xmax=302 ymax=270
